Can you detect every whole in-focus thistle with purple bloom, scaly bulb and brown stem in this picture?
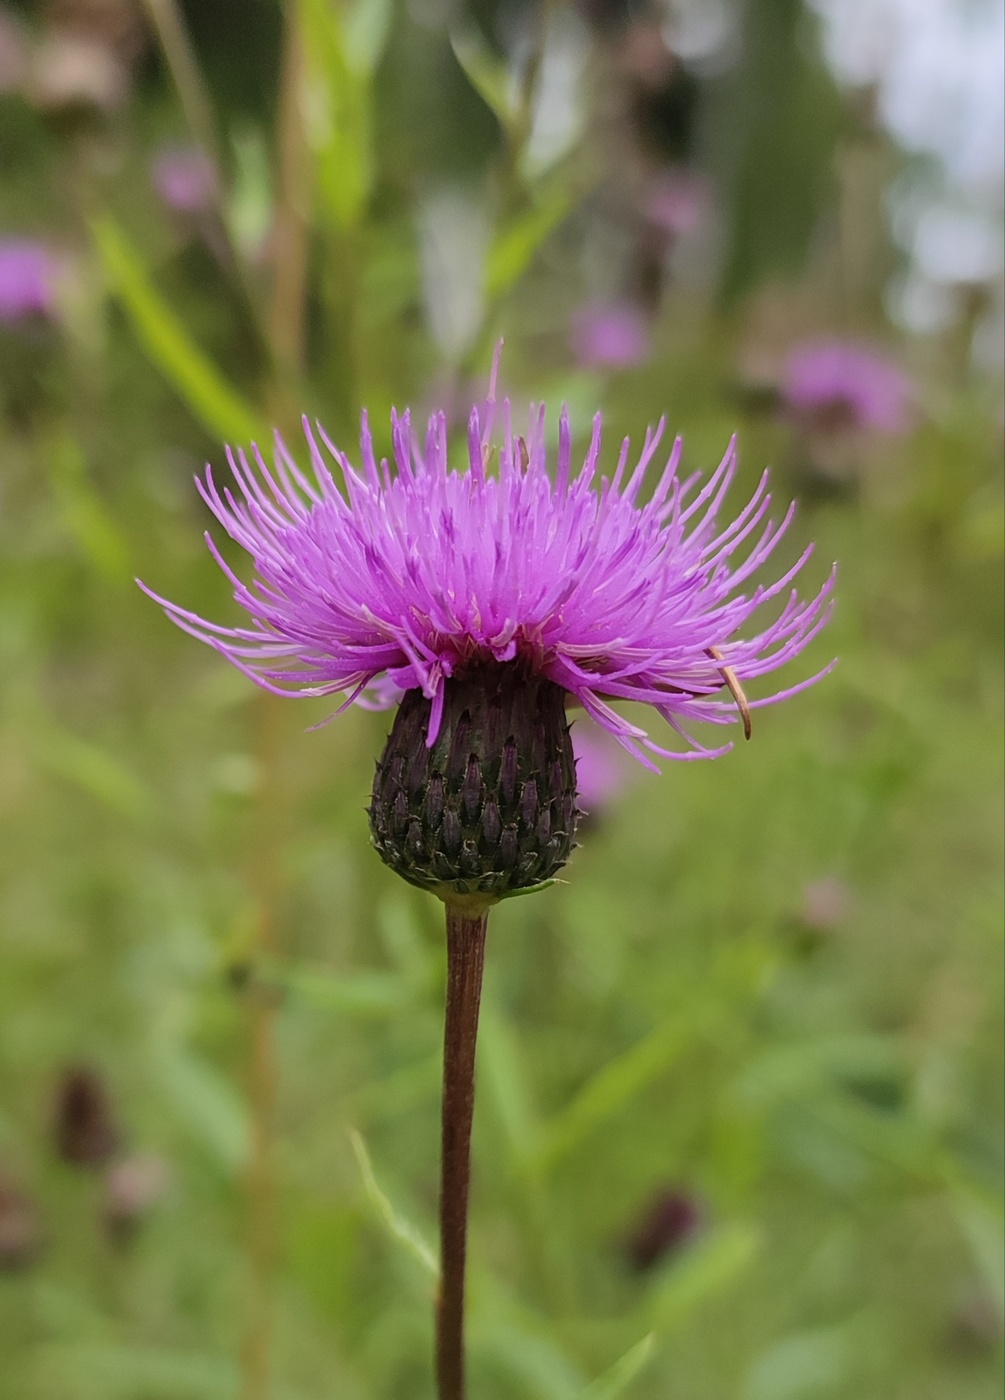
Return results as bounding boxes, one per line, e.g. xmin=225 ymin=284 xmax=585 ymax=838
xmin=141 ymin=357 xmax=834 ymax=1400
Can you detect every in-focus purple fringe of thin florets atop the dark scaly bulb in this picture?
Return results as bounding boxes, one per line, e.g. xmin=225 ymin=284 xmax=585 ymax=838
xmin=141 ymin=350 xmax=833 ymax=767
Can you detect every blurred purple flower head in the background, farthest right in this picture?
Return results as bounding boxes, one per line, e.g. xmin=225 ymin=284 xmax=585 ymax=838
xmin=781 ymin=340 xmax=914 ymax=434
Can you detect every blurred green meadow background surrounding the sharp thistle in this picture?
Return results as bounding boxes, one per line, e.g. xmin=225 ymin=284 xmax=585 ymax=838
xmin=0 ymin=0 xmax=1005 ymax=1400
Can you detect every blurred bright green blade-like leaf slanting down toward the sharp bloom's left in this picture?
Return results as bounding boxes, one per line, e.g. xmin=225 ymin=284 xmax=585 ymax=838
xmin=91 ymin=214 xmax=267 ymax=442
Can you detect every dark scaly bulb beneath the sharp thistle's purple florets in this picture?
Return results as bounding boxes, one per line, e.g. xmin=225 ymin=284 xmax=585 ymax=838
xmin=370 ymin=659 xmax=579 ymax=900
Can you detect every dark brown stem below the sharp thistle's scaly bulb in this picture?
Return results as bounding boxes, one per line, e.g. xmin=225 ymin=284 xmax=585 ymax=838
xmin=437 ymin=904 xmax=489 ymax=1400
